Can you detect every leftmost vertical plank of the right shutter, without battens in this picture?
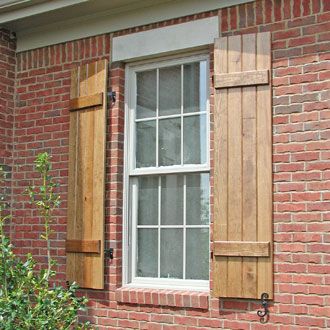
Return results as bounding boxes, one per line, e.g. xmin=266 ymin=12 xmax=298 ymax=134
xmin=212 ymin=38 xmax=228 ymax=297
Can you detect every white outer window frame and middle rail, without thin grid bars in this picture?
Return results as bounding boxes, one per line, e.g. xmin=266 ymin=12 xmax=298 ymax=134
xmin=122 ymin=53 xmax=210 ymax=291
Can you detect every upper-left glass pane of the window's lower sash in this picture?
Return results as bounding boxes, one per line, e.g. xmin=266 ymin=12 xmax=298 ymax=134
xmin=138 ymin=176 xmax=158 ymax=225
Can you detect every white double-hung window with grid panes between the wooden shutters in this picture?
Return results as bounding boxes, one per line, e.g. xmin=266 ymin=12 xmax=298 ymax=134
xmin=124 ymin=56 xmax=209 ymax=290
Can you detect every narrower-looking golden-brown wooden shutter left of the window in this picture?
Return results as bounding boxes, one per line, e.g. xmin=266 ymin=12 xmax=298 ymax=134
xmin=66 ymin=60 xmax=108 ymax=289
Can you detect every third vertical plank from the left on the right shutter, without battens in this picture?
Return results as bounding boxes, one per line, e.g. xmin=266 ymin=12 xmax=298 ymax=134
xmin=242 ymin=34 xmax=257 ymax=297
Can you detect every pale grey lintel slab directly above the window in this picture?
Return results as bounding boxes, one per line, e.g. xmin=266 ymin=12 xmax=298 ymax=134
xmin=112 ymin=16 xmax=219 ymax=62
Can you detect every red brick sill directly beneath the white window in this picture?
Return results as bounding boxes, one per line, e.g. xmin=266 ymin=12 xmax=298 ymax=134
xmin=116 ymin=287 xmax=209 ymax=309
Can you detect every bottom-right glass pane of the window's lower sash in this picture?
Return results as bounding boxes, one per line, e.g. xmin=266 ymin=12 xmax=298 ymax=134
xmin=186 ymin=228 xmax=209 ymax=280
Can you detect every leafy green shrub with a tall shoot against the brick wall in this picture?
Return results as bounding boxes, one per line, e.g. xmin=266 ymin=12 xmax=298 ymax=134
xmin=0 ymin=153 xmax=90 ymax=330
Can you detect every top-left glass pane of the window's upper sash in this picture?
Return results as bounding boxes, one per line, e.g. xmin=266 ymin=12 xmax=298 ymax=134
xmin=136 ymin=70 xmax=157 ymax=118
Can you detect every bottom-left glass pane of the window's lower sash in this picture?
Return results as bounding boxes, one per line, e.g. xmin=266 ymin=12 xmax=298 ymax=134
xmin=136 ymin=229 xmax=158 ymax=277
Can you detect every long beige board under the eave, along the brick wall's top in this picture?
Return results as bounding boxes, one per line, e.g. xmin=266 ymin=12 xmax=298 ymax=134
xmin=16 ymin=0 xmax=254 ymax=52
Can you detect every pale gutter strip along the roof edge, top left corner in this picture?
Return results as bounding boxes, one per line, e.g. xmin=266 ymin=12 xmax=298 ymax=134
xmin=0 ymin=0 xmax=88 ymax=24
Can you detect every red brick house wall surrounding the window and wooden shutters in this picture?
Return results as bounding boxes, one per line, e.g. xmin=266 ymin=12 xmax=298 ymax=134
xmin=5 ymin=0 xmax=330 ymax=330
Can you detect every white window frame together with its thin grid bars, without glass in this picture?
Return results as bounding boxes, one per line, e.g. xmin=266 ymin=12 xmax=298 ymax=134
xmin=123 ymin=55 xmax=210 ymax=290
